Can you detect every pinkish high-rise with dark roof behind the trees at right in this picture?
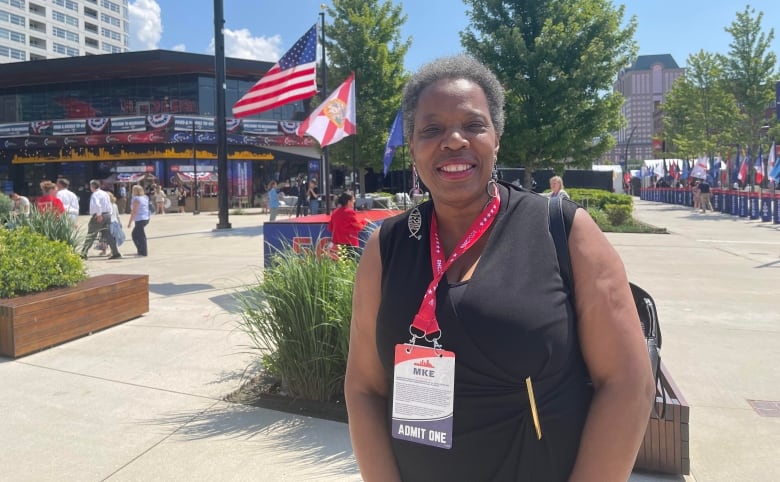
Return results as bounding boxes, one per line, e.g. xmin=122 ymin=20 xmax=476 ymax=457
xmin=603 ymin=54 xmax=685 ymax=168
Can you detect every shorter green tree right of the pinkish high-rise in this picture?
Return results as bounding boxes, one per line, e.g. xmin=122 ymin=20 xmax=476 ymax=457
xmin=663 ymin=50 xmax=742 ymax=159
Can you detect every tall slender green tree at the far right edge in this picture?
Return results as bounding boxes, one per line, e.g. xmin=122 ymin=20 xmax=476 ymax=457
xmin=722 ymin=5 xmax=777 ymax=152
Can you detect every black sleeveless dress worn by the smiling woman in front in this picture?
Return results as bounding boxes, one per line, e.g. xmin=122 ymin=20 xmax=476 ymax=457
xmin=376 ymin=185 xmax=592 ymax=482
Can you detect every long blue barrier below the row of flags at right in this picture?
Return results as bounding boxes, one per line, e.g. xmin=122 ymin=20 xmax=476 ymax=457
xmin=639 ymin=187 xmax=780 ymax=224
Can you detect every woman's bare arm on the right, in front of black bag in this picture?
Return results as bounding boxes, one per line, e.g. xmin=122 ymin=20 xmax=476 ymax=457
xmin=569 ymin=209 xmax=655 ymax=482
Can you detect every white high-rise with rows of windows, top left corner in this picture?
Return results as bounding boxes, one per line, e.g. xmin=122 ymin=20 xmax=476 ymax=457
xmin=0 ymin=0 xmax=130 ymax=63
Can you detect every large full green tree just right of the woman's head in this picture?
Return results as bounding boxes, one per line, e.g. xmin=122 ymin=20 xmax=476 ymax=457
xmin=461 ymin=0 xmax=636 ymax=186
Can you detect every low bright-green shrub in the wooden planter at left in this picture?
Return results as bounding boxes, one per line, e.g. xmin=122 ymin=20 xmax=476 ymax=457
xmin=0 ymin=226 xmax=87 ymax=298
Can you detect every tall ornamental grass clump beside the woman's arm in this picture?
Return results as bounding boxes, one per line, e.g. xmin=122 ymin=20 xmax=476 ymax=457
xmin=236 ymin=245 xmax=357 ymax=401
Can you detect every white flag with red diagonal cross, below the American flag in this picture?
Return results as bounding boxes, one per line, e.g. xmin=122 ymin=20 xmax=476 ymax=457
xmin=297 ymin=72 xmax=357 ymax=147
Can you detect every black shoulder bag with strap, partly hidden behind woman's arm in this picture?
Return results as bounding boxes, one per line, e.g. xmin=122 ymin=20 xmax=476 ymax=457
xmin=548 ymin=197 xmax=666 ymax=417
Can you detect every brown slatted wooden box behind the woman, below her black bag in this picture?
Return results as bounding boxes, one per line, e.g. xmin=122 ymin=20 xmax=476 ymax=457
xmin=634 ymin=363 xmax=691 ymax=475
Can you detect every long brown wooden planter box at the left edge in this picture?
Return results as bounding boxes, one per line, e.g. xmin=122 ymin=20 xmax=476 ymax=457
xmin=0 ymin=274 xmax=149 ymax=358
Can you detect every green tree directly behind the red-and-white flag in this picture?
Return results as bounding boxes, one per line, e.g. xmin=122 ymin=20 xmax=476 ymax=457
xmin=326 ymin=0 xmax=411 ymax=185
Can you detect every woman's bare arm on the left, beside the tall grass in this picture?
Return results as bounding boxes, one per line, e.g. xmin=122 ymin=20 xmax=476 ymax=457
xmin=344 ymin=230 xmax=401 ymax=482
